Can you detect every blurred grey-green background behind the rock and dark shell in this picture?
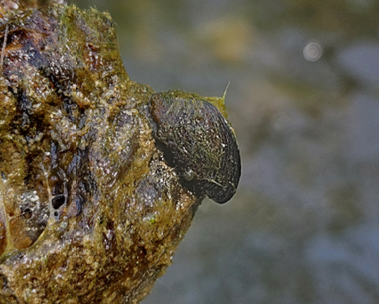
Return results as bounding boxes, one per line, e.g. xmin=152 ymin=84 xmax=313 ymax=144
xmin=72 ymin=0 xmax=379 ymax=304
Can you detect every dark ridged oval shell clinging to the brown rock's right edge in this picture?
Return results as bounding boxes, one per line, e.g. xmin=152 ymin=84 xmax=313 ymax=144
xmin=150 ymin=90 xmax=241 ymax=204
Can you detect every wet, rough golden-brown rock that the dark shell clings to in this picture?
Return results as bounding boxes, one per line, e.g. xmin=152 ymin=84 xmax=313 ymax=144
xmin=0 ymin=1 xmax=240 ymax=304
